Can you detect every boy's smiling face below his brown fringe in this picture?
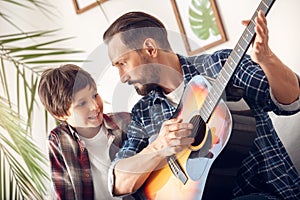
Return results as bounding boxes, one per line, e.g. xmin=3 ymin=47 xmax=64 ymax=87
xmin=66 ymin=85 xmax=103 ymax=129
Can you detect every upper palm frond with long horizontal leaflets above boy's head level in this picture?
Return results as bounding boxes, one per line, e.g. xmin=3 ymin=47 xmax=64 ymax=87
xmin=0 ymin=30 xmax=82 ymax=138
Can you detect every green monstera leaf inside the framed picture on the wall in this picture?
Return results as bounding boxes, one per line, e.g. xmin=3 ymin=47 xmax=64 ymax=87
xmin=189 ymin=0 xmax=219 ymax=40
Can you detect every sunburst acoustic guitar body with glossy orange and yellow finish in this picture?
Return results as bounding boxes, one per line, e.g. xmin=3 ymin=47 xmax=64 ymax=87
xmin=143 ymin=76 xmax=232 ymax=200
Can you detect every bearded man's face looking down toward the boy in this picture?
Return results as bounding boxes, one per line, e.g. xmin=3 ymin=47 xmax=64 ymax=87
xmin=108 ymin=35 xmax=160 ymax=96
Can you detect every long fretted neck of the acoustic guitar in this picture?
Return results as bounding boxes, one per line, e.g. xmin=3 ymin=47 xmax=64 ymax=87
xmin=200 ymin=0 xmax=275 ymax=122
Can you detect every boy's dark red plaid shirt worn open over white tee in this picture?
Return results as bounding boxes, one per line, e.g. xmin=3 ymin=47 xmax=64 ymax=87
xmin=49 ymin=113 xmax=130 ymax=200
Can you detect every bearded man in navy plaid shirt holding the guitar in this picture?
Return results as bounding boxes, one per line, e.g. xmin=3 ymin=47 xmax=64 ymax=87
xmin=103 ymin=11 xmax=300 ymax=199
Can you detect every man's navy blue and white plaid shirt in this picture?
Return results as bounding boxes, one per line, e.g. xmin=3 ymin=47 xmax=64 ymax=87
xmin=116 ymin=50 xmax=300 ymax=200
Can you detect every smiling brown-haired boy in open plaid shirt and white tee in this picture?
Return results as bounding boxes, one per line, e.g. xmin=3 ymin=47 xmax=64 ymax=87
xmin=38 ymin=64 xmax=130 ymax=199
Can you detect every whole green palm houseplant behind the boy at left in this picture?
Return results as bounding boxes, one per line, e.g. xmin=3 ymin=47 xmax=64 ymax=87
xmin=0 ymin=0 xmax=81 ymax=199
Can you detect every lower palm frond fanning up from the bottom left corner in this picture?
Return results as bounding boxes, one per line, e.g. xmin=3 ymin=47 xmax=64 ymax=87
xmin=0 ymin=98 xmax=49 ymax=199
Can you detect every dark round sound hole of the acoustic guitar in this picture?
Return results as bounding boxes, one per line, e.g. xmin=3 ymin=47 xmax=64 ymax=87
xmin=190 ymin=115 xmax=206 ymax=146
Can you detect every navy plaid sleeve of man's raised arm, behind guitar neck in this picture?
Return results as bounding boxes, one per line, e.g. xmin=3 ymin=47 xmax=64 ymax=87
xmin=202 ymin=49 xmax=300 ymax=115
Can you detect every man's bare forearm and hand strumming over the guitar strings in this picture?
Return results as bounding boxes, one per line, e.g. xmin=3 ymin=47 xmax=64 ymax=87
xmin=113 ymin=119 xmax=194 ymax=195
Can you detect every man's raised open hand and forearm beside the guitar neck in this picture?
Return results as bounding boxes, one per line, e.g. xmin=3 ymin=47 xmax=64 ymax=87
xmin=242 ymin=11 xmax=300 ymax=104
